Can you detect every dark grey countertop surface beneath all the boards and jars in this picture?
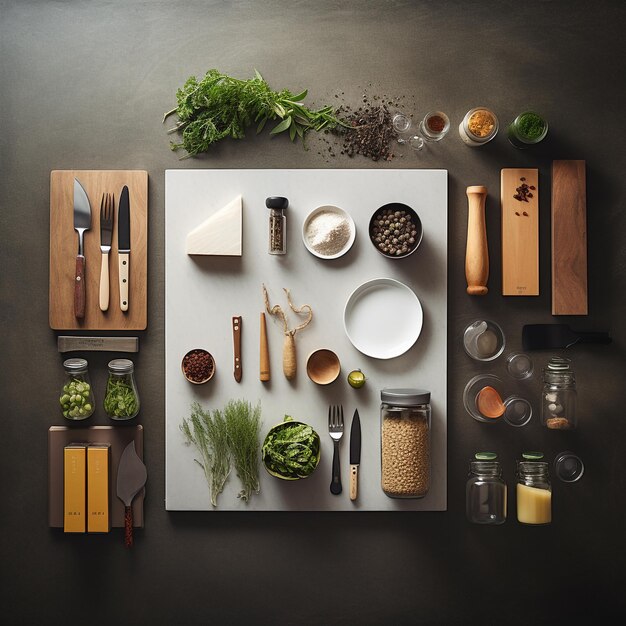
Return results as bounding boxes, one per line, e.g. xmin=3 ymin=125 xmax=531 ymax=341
xmin=0 ymin=0 xmax=626 ymax=625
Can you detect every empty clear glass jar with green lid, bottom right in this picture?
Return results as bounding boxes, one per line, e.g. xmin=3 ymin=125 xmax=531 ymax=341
xmin=465 ymin=452 xmax=507 ymax=524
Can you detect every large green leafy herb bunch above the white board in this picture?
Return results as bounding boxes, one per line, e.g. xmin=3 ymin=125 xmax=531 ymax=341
xmin=163 ymin=69 xmax=347 ymax=158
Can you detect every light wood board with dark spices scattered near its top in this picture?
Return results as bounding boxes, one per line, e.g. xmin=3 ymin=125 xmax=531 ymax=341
xmin=500 ymin=168 xmax=539 ymax=296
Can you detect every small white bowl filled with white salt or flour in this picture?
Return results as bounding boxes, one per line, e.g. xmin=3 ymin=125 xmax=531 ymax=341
xmin=302 ymin=204 xmax=356 ymax=259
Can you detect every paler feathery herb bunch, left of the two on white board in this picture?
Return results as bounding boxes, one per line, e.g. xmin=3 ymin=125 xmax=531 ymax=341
xmin=180 ymin=402 xmax=230 ymax=506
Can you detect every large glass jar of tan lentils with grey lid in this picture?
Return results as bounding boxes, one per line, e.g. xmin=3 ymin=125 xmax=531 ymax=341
xmin=380 ymin=389 xmax=431 ymax=498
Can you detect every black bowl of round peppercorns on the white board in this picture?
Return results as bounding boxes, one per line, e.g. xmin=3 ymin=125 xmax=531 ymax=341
xmin=369 ymin=202 xmax=424 ymax=259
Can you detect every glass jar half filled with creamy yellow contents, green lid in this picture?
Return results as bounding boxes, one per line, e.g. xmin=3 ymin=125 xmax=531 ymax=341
xmin=516 ymin=460 xmax=552 ymax=525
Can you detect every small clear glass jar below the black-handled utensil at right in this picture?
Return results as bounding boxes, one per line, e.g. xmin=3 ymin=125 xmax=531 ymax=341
xmin=541 ymin=357 xmax=576 ymax=430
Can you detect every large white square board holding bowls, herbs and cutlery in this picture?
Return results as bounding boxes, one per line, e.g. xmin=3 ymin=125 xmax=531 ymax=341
xmin=165 ymin=169 xmax=448 ymax=511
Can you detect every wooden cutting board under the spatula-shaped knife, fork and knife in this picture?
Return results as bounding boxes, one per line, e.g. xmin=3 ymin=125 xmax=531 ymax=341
xmin=49 ymin=170 xmax=148 ymax=330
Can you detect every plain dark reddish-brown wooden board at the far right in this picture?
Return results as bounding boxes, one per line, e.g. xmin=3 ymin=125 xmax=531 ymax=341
xmin=552 ymin=161 xmax=588 ymax=315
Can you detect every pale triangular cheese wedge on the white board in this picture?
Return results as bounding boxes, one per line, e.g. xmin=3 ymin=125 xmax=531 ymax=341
xmin=187 ymin=196 xmax=243 ymax=256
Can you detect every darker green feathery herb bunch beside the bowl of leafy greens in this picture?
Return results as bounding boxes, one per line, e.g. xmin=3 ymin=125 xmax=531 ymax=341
xmin=224 ymin=400 xmax=261 ymax=502
